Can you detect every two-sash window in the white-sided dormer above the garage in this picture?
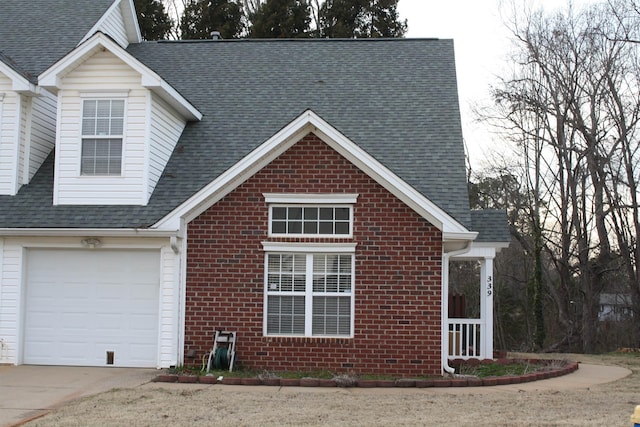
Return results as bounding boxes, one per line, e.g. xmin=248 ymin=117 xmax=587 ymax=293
xmin=80 ymin=99 xmax=125 ymax=176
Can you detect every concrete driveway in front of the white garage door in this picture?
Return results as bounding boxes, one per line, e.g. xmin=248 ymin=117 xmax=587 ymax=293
xmin=0 ymin=365 xmax=158 ymax=427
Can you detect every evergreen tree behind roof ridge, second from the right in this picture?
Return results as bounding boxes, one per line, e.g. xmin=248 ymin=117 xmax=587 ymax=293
xmin=249 ymin=0 xmax=311 ymax=38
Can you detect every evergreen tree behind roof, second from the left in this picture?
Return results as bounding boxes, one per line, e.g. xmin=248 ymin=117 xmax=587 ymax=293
xmin=180 ymin=0 xmax=243 ymax=40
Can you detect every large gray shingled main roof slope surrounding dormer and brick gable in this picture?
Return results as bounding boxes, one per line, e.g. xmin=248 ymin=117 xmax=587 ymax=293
xmin=0 ymin=39 xmax=472 ymax=229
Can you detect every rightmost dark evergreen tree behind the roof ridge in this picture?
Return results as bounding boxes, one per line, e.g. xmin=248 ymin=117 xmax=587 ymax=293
xmin=318 ymin=0 xmax=407 ymax=38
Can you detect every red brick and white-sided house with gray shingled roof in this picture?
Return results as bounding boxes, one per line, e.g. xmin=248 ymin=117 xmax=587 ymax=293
xmin=0 ymin=0 xmax=509 ymax=375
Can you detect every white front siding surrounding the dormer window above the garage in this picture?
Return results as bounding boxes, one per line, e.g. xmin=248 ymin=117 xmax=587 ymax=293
xmin=54 ymin=51 xmax=149 ymax=205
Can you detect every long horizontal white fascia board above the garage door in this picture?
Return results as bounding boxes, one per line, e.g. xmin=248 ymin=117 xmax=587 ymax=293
xmin=0 ymin=228 xmax=179 ymax=237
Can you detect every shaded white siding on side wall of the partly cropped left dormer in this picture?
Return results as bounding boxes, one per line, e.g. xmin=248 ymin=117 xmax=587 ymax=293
xmin=25 ymin=89 xmax=56 ymax=183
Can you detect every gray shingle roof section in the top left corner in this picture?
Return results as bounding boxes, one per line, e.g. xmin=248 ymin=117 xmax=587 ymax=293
xmin=0 ymin=0 xmax=114 ymax=82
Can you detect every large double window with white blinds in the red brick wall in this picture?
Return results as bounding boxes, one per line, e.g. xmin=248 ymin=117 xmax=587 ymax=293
xmin=263 ymin=243 xmax=355 ymax=337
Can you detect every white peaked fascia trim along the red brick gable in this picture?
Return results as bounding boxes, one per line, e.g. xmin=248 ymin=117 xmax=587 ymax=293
xmin=154 ymin=110 xmax=477 ymax=240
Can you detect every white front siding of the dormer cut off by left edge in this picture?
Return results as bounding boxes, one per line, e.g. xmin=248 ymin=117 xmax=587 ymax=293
xmin=0 ymin=74 xmax=20 ymax=195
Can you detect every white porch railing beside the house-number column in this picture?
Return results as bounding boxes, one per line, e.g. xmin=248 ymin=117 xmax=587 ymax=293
xmin=448 ymin=319 xmax=482 ymax=359
